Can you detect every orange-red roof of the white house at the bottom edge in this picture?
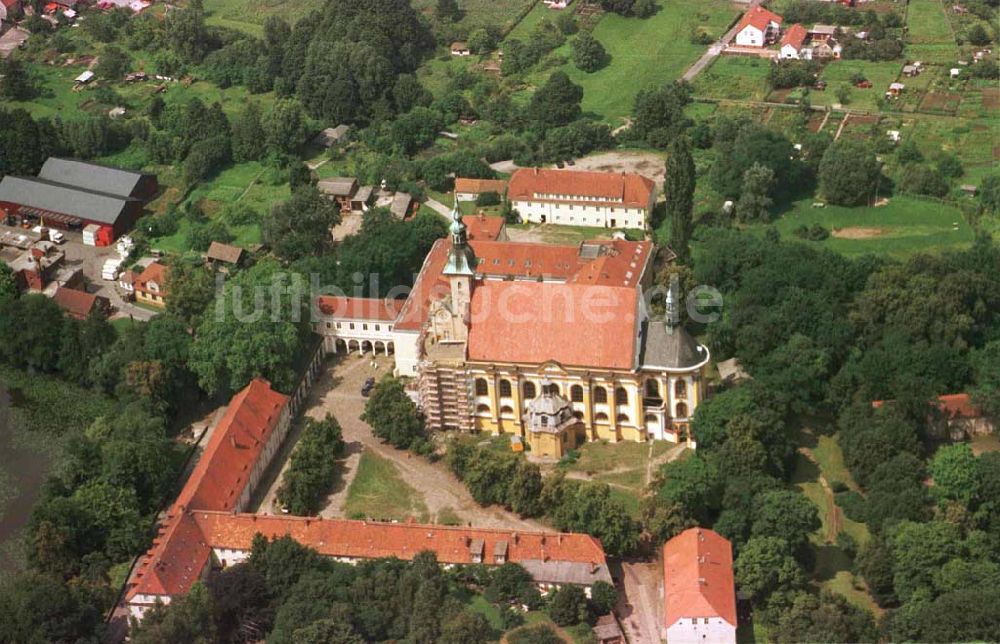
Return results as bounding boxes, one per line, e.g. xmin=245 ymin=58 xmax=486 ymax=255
xmin=663 ymin=528 xmax=736 ymax=628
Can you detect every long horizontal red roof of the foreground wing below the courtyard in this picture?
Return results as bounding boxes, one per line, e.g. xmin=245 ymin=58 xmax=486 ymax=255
xmin=193 ymin=511 xmax=605 ymax=564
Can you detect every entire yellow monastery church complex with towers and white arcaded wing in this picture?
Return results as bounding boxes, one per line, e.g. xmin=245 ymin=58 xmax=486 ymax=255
xmin=316 ymin=203 xmax=709 ymax=458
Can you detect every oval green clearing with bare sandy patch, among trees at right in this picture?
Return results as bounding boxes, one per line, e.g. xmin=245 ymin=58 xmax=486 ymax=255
xmin=755 ymin=197 xmax=975 ymax=257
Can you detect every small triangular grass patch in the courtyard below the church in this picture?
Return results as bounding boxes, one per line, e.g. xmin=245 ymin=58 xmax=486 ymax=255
xmin=344 ymin=451 xmax=428 ymax=521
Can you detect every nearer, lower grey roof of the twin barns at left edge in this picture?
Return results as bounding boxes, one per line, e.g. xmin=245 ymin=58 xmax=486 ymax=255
xmin=0 ymin=175 xmax=133 ymax=224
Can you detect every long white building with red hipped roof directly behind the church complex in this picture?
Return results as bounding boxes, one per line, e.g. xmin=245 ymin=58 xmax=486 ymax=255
xmin=507 ymin=168 xmax=656 ymax=229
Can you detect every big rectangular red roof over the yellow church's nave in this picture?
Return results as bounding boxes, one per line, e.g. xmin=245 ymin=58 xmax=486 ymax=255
xmin=467 ymin=280 xmax=639 ymax=369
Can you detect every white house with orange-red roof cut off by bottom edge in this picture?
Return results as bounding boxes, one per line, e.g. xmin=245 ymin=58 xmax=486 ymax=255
xmin=663 ymin=528 xmax=737 ymax=644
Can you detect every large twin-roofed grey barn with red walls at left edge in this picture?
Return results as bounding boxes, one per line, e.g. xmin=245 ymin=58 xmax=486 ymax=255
xmin=0 ymin=157 xmax=157 ymax=246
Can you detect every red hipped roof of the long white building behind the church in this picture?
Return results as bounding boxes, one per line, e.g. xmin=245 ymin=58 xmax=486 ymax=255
xmin=507 ymin=168 xmax=655 ymax=208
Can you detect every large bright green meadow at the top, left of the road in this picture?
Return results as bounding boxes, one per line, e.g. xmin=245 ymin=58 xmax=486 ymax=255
xmin=512 ymin=0 xmax=738 ymax=124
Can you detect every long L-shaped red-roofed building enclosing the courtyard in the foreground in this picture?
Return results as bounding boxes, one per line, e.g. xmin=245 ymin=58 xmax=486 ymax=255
xmin=125 ymin=378 xmax=611 ymax=619
